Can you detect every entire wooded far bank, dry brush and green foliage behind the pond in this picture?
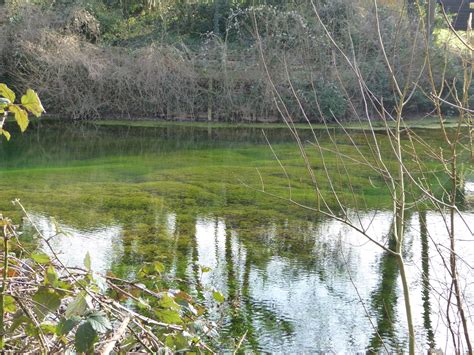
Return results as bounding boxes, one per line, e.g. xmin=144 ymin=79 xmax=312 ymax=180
xmin=0 ymin=0 xmax=470 ymax=121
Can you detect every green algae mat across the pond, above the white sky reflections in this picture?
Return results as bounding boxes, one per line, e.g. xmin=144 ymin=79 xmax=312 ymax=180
xmin=0 ymin=125 xmax=462 ymax=226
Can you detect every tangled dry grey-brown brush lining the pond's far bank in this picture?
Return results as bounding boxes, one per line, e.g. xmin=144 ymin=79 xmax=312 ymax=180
xmin=0 ymin=0 xmax=466 ymax=121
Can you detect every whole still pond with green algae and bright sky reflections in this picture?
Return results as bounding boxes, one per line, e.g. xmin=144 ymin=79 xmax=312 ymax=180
xmin=0 ymin=123 xmax=474 ymax=353
